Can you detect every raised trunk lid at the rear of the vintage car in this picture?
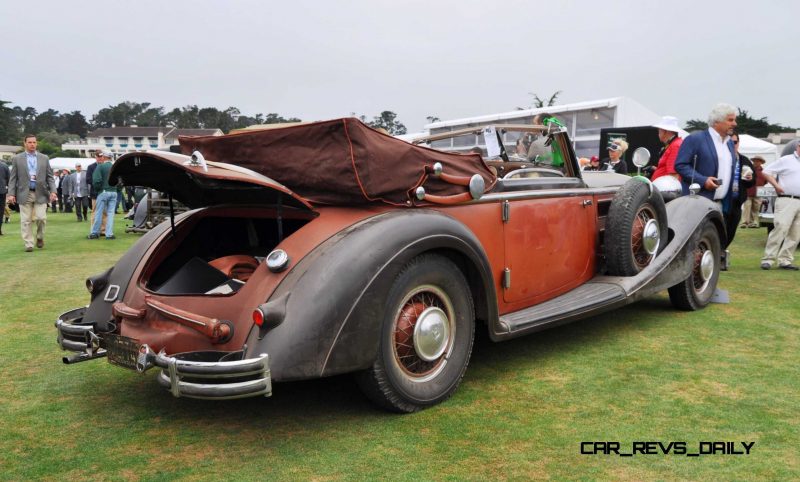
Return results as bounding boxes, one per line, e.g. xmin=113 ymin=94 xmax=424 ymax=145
xmin=109 ymin=151 xmax=313 ymax=211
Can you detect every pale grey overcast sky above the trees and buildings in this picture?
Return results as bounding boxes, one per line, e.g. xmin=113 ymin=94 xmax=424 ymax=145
xmin=0 ymin=0 xmax=800 ymax=132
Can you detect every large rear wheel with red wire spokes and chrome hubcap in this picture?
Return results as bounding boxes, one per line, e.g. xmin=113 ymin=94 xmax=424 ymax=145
xmin=357 ymin=254 xmax=475 ymax=413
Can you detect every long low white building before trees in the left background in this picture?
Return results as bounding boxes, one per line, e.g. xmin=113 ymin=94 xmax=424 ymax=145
xmin=61 ymin=127 xmax=222 ymax=157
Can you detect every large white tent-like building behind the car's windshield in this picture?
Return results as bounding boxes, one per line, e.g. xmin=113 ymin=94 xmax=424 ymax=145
xmin=424 ymin=97 xmax=661 ymax=156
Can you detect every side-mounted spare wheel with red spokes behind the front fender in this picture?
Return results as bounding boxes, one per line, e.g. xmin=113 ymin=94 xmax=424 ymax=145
xmin=603 ymin=178 xmax=667 ymax=276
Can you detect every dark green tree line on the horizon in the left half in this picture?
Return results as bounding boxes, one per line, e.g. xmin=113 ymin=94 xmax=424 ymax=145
xmin=0 ymin=100 xmax=407 ymax=156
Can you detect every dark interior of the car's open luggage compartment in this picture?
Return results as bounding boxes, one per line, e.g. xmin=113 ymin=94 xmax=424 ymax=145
xmin=145 ymin=215 xmax=310 ymax=295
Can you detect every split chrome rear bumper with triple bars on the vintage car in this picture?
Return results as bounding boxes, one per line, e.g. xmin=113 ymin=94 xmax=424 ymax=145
xmin=55 ymin=307 xmax=272 ymax=400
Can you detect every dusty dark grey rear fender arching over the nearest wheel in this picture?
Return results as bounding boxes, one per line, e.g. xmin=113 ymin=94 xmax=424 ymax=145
xmin=247 ymin=209 xmax=497 ymax=380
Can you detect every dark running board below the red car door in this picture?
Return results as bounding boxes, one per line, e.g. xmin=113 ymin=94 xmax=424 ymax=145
xmin=498 ymin=282 xmax=628 ymax=338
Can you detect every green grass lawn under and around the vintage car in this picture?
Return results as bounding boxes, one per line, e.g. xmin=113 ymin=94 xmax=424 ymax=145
xmin=0 ymin=214 xmax=800 ymax=480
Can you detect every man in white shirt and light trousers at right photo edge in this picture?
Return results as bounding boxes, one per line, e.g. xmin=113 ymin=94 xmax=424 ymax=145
xmin=761 ymin=142 xmax=800 ymax=271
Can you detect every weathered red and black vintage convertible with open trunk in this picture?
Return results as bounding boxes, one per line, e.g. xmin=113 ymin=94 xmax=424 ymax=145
xmin=56 ymin=118 xmax=725 ymax=412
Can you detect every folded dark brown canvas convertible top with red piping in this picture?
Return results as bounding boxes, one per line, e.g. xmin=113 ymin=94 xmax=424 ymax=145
xmin=179 ymin=118 xmax=497 ymax=206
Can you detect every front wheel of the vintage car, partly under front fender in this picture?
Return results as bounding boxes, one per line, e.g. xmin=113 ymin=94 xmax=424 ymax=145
xmin=668 ymin=223 xmax=722 ymax=311
